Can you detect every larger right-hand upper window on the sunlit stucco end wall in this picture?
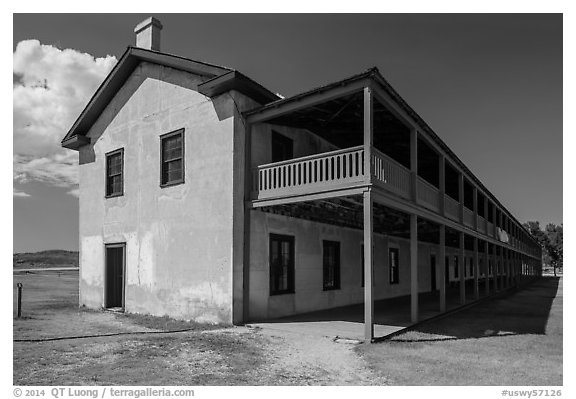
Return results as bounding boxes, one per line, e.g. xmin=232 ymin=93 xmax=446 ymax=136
xmin=160 ymin=129 xmax=184 ymax=186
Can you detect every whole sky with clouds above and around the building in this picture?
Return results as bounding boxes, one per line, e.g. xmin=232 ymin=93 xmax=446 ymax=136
xmin=13 ymin=14 xmax=563 ymax=252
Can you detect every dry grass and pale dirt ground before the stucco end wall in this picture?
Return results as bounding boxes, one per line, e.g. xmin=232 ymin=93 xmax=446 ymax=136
xmin=13 ymin=272 xmax=382 ymax=385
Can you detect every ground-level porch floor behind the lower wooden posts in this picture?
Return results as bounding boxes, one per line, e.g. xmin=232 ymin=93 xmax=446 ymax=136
xmin=249 ymin=281 xmax=510 ymax=341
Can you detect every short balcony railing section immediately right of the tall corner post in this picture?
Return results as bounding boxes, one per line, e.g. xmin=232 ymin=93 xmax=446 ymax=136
xmin=372 ymin=148 xmax=411 ymax=198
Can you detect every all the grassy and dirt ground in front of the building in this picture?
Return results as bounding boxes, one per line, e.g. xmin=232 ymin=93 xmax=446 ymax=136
xmin=13 ymin=271 xmax=562 ymax=385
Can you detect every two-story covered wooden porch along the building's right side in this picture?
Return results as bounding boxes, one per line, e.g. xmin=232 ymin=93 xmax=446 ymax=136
xmin=244 ymin=67 xmax=540 ymax=342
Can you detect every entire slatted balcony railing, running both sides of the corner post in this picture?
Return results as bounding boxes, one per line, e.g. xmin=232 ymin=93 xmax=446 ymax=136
xmin=252 ymin=146 xmax=508 ymax=244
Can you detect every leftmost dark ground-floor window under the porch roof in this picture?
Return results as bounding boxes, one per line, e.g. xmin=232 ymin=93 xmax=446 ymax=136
xmin=270 ymin=234 xmax=294 ymax=295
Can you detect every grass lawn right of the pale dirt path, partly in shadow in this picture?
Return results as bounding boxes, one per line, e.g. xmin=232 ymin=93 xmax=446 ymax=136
xmin=357 ymin=277 xmax=562 ymax=385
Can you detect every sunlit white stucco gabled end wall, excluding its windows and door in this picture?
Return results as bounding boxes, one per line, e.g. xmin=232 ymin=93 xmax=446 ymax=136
xmin=80 ymin=63 xmax=235 ymax=323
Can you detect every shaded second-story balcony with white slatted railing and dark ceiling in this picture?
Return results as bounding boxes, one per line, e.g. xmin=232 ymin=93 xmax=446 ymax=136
xmin=247 ymin=75 xmax=528 ymax=255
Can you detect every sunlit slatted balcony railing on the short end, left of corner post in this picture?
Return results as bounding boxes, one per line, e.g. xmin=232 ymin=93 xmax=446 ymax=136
xmin=252 ymin=146 xmax=364 ymax=199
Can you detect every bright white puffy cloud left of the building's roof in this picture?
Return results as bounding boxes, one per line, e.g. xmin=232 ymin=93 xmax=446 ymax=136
xmin=13 ymin=40 xmax=116 ymax=195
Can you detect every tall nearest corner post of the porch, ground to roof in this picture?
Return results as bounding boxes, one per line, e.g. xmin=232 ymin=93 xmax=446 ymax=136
xmin=363 ymin=87 xmax=374 ymax=342
